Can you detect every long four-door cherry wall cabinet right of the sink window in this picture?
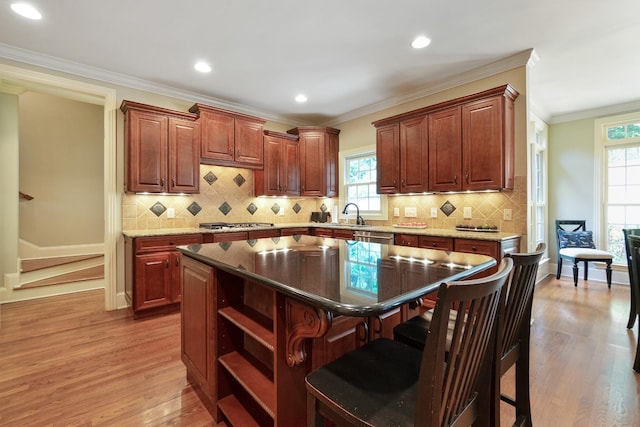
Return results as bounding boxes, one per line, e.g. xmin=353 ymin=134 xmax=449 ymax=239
xmin=373 ymin=85 xmax=518 ymax=193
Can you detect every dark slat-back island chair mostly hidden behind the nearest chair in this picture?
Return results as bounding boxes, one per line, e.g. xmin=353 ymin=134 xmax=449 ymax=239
xmin=393 ymin=243 xmax=547 ymax=426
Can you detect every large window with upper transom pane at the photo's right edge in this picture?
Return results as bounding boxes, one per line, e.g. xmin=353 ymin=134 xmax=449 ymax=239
xmin=596 ymin=114 xmax=640 ymax=265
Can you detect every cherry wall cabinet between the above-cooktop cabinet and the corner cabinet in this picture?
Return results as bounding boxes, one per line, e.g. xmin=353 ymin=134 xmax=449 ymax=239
xmin=254 ymin=130 xmax=300 ymax=196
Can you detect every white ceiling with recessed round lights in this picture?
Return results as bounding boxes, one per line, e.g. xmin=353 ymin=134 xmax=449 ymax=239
xmin=0 ymin=0 xmax=640 ymax=124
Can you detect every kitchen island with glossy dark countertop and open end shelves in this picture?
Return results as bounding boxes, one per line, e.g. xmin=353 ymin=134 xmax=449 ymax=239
xmin=178 ymin=235 xmax=496 ymax=426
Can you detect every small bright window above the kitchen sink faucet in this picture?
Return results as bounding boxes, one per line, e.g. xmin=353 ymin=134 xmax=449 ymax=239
xmin=343 ymin=150 xmax=387 ymax=220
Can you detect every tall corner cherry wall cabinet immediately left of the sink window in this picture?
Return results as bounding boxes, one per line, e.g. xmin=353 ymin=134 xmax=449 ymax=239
xmin=287 ymin=126 xmax=340 ymax=197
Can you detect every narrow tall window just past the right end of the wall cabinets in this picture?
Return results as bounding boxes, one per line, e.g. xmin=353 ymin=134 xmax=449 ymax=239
xmin=529 ymin=117 xmax=549 ymax=251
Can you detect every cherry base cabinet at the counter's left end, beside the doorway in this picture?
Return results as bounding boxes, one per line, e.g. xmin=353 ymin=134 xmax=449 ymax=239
xmin=125 ymin=234 xmax=202 ymax=318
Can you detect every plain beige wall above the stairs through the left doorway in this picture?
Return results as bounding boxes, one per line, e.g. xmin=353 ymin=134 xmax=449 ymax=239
xmin=19 ymin=92 xmax=104 ymax=247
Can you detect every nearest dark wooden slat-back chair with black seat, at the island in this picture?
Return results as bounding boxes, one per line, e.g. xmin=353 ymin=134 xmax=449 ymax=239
xmin=306 ymin=258 xmax=513 ymax=427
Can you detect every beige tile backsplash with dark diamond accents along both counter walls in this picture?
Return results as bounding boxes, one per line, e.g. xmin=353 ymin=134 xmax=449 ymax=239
xmin=122 ymin=165 xmax=527 ymax=241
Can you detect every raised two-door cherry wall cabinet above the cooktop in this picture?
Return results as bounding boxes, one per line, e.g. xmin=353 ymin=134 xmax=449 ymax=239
xmin=189 ymin=104 xmax=266 ymax=169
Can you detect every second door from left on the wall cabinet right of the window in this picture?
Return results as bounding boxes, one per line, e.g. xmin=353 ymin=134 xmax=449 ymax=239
xmin=400 ymin=116 xmax=428 ymax=193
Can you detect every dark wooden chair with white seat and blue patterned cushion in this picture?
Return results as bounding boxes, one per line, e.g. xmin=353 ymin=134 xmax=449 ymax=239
xmin=556 ymin=219 xmax=613 ymax=288
